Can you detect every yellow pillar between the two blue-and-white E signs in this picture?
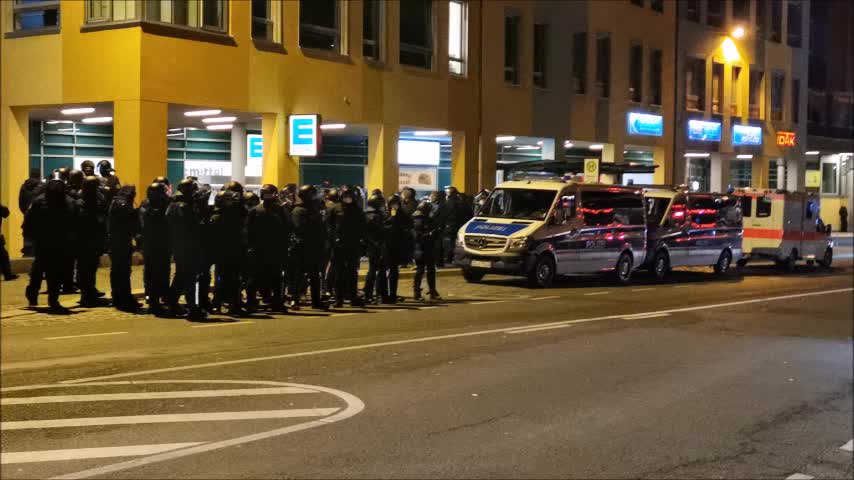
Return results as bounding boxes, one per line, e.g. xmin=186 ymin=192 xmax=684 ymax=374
xmin=262 ymin=113 xmax=299 ymax=187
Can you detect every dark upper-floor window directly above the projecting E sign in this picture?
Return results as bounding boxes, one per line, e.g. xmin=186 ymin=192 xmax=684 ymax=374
xmin=299 ymin=0 xmax=344 ymax=53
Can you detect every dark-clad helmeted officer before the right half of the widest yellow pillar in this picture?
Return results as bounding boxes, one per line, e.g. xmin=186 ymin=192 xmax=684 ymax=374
xmin=139 ymin=179 xmax=172 ymax=316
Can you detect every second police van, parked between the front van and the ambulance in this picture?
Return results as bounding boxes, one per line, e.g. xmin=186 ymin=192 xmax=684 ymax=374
xmin=644 ymin=187 xmax=742 ymax=280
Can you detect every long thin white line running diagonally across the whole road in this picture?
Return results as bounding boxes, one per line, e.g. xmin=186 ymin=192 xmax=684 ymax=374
xmin=56 ymin=287 xmax=854 ymax=384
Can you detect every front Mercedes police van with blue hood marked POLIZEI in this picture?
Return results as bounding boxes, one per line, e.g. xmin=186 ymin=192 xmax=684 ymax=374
xmin=454 ymin=179 xmax=646 ymax=287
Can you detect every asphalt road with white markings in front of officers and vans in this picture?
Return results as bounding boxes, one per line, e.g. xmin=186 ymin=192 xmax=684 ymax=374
xmin=0 ymin=259 xmax=854 ymax=479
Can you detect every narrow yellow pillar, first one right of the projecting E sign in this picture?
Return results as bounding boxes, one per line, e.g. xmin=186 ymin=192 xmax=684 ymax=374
xmin=366 ymin=124 xmax=400 ymax=196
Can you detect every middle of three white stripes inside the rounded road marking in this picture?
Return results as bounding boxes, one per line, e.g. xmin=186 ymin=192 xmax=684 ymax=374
xmin=0 ymin=408 xmax=339 ymax=430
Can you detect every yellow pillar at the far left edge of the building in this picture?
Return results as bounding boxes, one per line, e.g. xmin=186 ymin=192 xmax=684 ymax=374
xmin=0 ymin=105 xmax=30 ymax=258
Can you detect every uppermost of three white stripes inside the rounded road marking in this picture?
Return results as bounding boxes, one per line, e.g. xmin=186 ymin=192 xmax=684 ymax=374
xmin=0 ymin=387 xmax=315 ymax=405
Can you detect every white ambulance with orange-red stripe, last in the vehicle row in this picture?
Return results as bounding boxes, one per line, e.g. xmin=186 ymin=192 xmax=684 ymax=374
xmin=736 ymin=189 xmax=833 ymax=270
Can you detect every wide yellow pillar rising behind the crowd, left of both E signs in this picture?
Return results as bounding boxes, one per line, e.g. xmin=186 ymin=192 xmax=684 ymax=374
xmin=113 ymin=100 xmax=169 ymax=202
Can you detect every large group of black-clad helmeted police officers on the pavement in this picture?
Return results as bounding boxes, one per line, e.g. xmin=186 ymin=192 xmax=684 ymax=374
xmin=20 ymin=160 xmax=485 ymax=320
